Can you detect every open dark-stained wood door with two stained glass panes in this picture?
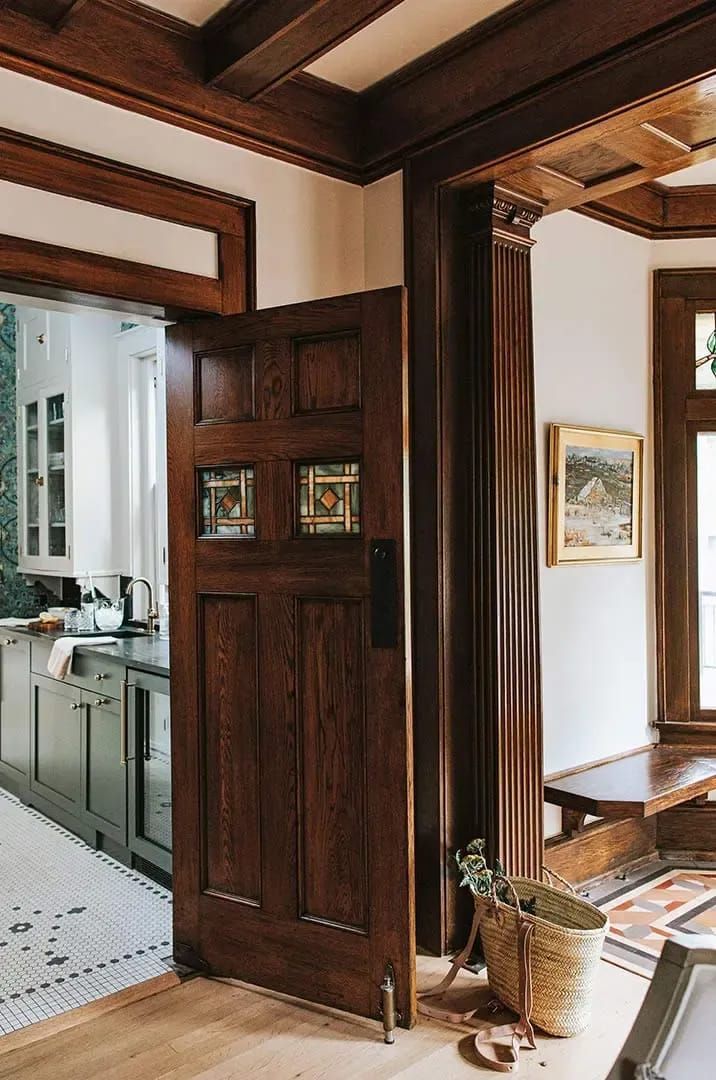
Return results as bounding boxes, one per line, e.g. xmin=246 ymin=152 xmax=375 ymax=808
xmin=167 ymin=288 xmax=415 ymax=1024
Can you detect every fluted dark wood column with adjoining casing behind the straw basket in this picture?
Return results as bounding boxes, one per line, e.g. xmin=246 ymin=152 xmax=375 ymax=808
xmin=406 ymin=171 xmax=543 ymax=953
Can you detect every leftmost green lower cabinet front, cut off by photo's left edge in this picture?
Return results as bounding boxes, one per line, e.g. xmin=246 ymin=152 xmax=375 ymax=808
xmin=0 ymin=627 xmax=30 ymax=795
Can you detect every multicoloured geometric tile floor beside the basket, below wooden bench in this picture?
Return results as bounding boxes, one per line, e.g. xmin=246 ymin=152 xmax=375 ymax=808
xmin=594 ymin=862 xmax=716 ymax=977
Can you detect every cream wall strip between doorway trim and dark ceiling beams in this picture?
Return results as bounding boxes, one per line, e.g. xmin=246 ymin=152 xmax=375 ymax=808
xmin=0 ymin=69 xmax=365 ymax=307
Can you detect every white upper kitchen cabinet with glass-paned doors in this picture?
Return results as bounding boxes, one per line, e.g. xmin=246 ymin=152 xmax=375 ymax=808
xmin=16 ymin=308 xmax=129 ymax=582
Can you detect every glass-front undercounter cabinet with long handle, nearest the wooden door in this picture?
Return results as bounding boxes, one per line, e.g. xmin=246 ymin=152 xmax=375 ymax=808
xmin=127 ymin=671 xmax=172 ymax=873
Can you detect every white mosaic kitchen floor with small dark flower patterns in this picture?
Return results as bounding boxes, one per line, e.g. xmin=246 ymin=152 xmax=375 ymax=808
xmin=0 ymin=789 xmax=172 ymax=1035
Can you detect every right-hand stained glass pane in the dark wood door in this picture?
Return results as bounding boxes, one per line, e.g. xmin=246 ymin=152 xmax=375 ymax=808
xmin=298 ymin=461 xmax=361 ymax=536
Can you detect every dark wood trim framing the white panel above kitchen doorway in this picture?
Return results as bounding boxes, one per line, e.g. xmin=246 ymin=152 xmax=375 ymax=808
xmin=0 ymin=129 xmax=256 ymax=314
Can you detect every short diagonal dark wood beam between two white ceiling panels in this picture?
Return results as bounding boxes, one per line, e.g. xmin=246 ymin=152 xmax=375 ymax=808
xmin=205 ymin=0 xmax=400 ymax=100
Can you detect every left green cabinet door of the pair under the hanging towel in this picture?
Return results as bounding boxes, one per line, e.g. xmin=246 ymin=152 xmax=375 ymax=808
xmin=29 ymin=675 xmax=82 ymax=818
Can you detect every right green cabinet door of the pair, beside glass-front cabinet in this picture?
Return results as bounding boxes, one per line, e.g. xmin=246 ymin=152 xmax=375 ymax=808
xmin=82 ymin=691 xmax=126 ymax=846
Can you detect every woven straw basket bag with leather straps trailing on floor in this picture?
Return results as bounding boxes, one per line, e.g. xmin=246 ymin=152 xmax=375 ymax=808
xmin=418 ymin=868 xmax=609 ymax=1072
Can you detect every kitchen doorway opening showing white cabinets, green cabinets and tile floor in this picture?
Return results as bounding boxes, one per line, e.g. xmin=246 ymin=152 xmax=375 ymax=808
xmin=0 ymin=293 xmax=178 ymax=1035
